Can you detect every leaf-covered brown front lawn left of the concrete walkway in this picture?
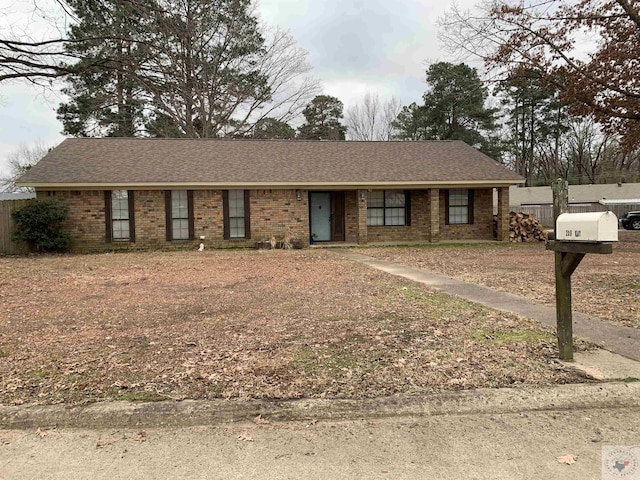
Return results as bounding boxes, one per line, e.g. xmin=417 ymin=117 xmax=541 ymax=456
xmin=0 ymin=249 xmax=581 ymax=404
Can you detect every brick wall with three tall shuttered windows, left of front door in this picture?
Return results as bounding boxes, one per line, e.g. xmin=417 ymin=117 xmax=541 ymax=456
xmin=37 ymin=190 xmax=309 ymax=252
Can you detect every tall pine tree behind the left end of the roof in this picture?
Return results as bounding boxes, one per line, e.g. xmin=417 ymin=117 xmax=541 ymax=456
xmin=58 ymin=0 xmax=151 ymax=137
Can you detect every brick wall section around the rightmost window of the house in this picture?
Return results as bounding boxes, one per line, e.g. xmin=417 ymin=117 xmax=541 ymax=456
xmin=440 ymin=188 xmax=493 ymax=240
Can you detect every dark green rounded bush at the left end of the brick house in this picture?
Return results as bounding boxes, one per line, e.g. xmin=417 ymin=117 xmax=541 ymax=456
xmin=11 ymin=199 xmax=71 ymax=253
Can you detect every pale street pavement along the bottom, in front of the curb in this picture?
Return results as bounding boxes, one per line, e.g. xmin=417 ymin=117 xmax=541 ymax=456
xmin=0 ymin=407 xmax=640 ymax=480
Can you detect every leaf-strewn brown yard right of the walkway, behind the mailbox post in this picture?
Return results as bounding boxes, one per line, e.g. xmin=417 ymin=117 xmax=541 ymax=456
xmin=358 ymin=242 xmax=640 ymax=328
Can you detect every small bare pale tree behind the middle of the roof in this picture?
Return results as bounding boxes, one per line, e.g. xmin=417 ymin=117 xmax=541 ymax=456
xmin=345 ymin=93 xmax=402 ymax=141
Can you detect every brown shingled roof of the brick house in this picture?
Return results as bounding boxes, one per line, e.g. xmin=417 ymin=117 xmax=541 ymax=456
xmin=17 ymin=138 xmax=524 ymax=189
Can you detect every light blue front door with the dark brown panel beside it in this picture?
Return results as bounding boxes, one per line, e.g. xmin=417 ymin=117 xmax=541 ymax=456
xmin=309 ymin=192 xmax=345 ymax=242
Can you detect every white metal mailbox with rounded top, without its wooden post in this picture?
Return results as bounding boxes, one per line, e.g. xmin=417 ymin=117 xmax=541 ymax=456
xmin=555 ymin=212 xmax=618 ymax=242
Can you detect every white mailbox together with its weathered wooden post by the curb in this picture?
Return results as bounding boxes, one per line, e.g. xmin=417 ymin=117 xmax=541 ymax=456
xmin=546 ymin=179 xmax=618 ymax=360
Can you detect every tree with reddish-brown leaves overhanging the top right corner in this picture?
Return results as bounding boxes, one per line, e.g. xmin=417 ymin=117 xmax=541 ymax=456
xmin=440 ymin=0 xmax=640 ymax=149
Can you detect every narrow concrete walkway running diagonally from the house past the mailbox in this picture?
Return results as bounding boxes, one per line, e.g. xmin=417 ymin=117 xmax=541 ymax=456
xmin=331 ymin=248 xmax=640 ymax=361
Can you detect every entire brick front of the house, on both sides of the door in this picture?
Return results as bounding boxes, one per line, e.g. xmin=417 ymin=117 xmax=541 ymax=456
xmin=37 ymin=188 xmax=508 ymax=252
